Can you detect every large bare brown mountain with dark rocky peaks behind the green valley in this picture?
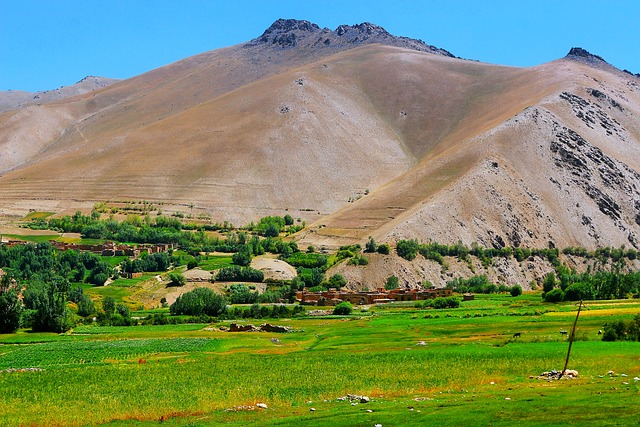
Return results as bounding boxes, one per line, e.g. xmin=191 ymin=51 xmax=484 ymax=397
xmin=0 ymin=20 xmax=640 ymax=248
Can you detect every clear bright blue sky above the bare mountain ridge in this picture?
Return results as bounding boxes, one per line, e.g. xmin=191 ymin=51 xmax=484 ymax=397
xmin=0 ymin=0 xmax=640 ymax=91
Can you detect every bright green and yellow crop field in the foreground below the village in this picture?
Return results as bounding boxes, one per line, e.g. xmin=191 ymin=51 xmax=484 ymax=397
xmin=0 ymin=294 xmax=640 ymax=427
